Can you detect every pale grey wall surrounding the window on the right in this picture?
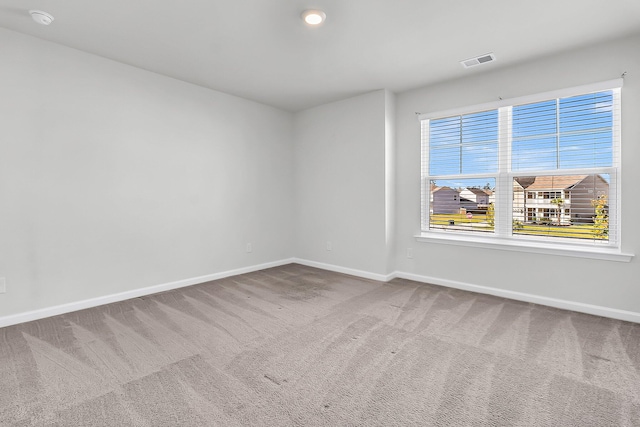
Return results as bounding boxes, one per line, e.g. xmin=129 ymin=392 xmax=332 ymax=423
xmin=396 ymin=36 xmax=640 ymax=313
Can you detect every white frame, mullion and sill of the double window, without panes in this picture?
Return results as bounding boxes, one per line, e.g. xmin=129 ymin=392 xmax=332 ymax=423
xmin=415 ymin=79 xmax=633 ymax=262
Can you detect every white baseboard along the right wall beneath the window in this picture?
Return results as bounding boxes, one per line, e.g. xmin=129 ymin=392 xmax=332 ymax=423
xmin=393 ymin=271 xmax=640 ymax=323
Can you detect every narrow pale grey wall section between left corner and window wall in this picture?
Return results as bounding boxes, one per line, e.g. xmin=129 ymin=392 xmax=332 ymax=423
xmin=294 ymin=90 xmax=392 ymax=274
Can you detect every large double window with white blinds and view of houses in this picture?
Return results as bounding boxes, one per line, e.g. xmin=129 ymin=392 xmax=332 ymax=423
xmin=420 ymin=80 xmax=622 ymax=246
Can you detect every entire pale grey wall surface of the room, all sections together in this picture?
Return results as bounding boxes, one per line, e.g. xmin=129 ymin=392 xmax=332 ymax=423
xmin=0 ymin=25 xmax=640 ymax=324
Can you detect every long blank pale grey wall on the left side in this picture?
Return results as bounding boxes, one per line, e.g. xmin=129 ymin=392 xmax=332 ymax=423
xmin=0 ymin=29 xmax=293 ymax=317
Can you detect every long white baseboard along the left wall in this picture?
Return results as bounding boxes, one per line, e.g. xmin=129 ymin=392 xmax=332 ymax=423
xmin=0 ymin=258 xmax=294 ymax=328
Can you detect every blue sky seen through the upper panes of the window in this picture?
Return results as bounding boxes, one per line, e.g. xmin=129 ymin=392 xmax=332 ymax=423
xmin=429 ymin=91 xmax=613 ymax=186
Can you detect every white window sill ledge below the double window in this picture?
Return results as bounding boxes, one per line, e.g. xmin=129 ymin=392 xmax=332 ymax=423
xmin=415 ymin=232 xmax=635 ymax=262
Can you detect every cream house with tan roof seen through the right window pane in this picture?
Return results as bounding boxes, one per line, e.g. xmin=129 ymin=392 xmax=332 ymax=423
xmin=513 ymin=175 xmax=609 ymax=224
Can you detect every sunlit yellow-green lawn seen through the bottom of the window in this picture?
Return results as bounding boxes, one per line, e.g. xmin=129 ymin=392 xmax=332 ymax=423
xmin=431 ymin=214 xmax=606 ymax=240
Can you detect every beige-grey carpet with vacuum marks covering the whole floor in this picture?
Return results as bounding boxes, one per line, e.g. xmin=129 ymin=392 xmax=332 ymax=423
xmin=0 ymin=264 xmax=640 ymax=426
